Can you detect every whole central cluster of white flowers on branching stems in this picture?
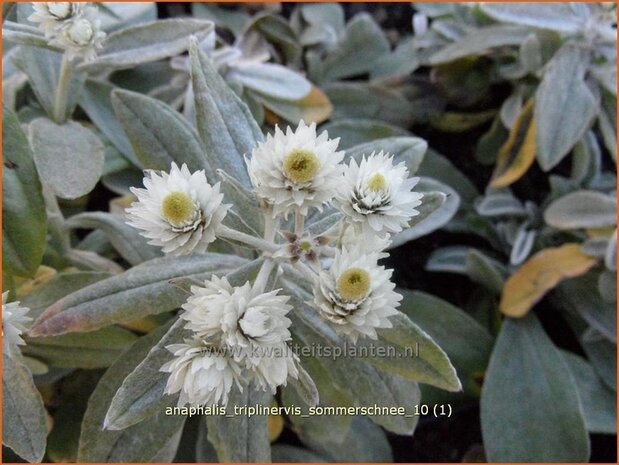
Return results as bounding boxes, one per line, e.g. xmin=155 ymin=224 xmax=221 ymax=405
xmin=127 ymin=121 xmax=422 ymax=405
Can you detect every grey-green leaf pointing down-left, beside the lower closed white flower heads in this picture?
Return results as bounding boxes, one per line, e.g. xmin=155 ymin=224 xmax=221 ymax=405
xmin=104 ymin=318 xmax=188 ymax=431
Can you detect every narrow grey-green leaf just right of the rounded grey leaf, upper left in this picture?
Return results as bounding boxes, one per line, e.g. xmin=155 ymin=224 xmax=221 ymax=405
xmin=79 ymin=79 xmax=141 ymax=167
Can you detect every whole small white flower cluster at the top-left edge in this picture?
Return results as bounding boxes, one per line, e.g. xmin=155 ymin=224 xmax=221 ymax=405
xmin=28 ymin=2 xmax=106 ymax=61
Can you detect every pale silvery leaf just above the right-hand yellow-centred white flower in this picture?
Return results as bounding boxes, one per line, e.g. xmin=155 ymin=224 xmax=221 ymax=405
xmin=346 ymin=138 xmax=428 ymax=176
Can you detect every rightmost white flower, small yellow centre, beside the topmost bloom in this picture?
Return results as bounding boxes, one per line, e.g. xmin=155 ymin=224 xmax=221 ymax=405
xmin=335 ymin=151 xmax=423 ymax=237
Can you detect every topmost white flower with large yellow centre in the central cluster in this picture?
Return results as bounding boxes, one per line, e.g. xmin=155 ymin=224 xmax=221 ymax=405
xmin=247 ymin=121 xmax=344 ymax=216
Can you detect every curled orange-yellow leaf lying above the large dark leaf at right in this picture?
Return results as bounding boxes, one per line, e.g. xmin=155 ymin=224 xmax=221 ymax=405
xmin=500 ymin=244 xmax=596 ymax=318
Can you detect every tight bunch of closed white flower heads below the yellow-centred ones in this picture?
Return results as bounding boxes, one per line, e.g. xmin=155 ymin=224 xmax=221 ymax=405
xmin=162 ymin=277 xmax=298 ymax=406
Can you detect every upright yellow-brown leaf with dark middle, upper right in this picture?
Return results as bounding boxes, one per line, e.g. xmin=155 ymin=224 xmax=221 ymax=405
xmin=490 ymin=99 xmax=536 ymax=187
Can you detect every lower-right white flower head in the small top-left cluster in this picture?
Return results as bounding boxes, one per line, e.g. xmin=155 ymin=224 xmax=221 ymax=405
xmin=50 ymin=6 xmax=106 ymax=61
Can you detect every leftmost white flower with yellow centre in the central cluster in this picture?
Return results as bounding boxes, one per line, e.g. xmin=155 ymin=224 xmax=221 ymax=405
xmin=127 ymin=163 xmax=229 ymax=255
